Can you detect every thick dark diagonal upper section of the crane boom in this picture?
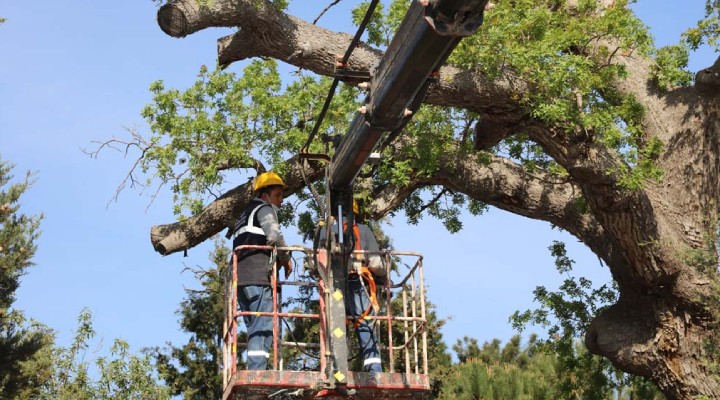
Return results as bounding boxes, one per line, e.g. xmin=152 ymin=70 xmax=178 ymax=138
xmin=329 ymin=0 xmax=488 ymax=190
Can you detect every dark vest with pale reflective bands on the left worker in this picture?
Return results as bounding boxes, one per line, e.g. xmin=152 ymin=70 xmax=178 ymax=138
xmin=233 ymin=198 xmax=272 ymax=286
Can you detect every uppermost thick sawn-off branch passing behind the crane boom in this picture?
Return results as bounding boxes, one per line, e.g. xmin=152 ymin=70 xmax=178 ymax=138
xmin=158 ymin=0 xmax=527 ymax=115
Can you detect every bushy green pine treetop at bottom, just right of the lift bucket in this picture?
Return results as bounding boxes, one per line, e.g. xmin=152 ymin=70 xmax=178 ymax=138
xmin=444 ymin=334 xmax=665 ymax=400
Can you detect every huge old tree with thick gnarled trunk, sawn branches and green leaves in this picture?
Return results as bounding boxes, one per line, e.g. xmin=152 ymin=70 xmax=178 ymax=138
xmin=101 ymin=0 xmax=720 ymax=399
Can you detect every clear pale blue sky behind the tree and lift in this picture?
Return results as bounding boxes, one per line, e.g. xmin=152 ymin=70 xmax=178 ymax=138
xmin=0 ymin=0 xmax=716 ymax=362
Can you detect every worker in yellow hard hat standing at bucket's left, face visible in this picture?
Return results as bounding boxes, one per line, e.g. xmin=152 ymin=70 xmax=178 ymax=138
xmin=233 ymin=172 xmax=292 ymax=370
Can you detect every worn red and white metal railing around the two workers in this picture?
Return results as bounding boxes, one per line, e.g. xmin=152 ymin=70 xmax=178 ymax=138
xmin=222 ymin=245 xmax=428 ymax=388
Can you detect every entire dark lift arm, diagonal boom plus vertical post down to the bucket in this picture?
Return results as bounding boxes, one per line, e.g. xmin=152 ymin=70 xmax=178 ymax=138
xmin=326 ymin=0 xmax=488 ymax=390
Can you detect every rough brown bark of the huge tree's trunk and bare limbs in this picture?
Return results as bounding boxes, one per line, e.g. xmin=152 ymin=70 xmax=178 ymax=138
xmin=156 ymin=0 xmax=720 ymax=399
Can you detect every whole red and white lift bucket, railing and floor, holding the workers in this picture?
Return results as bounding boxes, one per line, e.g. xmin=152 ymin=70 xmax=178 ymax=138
xmin=222 ymin=246 xmax=430 ymax=400
